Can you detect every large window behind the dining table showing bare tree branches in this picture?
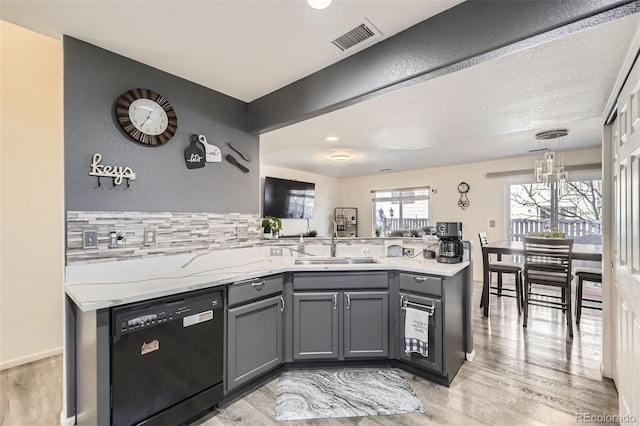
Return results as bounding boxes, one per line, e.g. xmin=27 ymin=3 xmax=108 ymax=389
xmin=509 ymin=179 xmax=602 ymax=244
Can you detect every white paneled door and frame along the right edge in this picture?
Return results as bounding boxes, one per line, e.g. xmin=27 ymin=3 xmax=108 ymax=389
xmin=602 ymin=23 xmax=640 ymax=422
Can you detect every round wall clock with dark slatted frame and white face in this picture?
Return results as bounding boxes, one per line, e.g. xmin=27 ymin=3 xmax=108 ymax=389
xmin=116 ymin=89 xmax=178 ymax=146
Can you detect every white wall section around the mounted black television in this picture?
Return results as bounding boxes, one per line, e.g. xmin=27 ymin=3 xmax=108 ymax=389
xmin=260 ymin=164 xmax=340 ymax=236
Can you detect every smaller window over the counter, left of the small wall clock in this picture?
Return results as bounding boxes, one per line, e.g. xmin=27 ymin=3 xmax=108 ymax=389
xmin=371 ymin=186 xmax=430 ymax=235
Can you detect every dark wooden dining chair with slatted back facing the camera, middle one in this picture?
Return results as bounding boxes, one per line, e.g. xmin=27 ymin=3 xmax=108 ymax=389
xmin=522 ymin=237 xmax=573 ymax=337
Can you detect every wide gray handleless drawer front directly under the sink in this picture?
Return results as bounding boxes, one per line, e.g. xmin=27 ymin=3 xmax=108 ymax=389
xmin=293 ymin=272 xmax=389 ymax=290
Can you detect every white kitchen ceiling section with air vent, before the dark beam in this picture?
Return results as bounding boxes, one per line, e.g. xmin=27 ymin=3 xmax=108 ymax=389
xmin=0 ymin=0 xmax=461 ymax=102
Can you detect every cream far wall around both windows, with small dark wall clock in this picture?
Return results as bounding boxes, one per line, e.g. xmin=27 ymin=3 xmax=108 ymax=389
xmin=339 ymin=148 xmax=601 ymax=280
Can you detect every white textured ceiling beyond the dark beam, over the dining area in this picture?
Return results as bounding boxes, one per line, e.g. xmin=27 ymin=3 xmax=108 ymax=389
xmin=261 ymin=14 xmax=640 ymax=176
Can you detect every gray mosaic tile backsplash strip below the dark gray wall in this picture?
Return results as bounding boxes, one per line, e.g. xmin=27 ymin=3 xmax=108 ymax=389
xmin=67 ymin=211 xmax=262 ymax=264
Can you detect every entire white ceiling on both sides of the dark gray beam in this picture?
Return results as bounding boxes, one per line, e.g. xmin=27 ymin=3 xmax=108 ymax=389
xmin=0 ymin=0 xmax=640 ymax=176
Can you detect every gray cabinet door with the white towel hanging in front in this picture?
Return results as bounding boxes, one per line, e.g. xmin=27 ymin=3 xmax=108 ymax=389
xmin=398 ymin=293 xmax=446 ymax=374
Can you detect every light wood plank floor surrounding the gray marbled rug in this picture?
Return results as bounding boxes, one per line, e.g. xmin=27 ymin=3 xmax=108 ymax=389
xmin=0 ymin=283 xmax=618 ymax=426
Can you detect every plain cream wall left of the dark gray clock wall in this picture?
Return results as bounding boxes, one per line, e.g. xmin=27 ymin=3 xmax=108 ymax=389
xmin=0 ymin=21 xmax=64 ymax=369
